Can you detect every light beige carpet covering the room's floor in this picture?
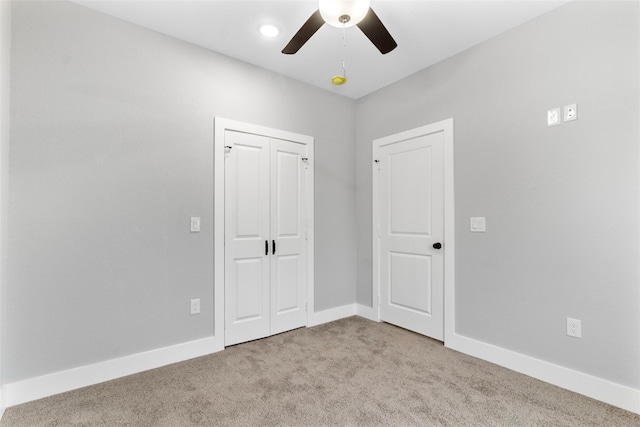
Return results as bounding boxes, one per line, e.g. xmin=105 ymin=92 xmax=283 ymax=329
xmin=0 ymin=317 xmax=640 ymax=427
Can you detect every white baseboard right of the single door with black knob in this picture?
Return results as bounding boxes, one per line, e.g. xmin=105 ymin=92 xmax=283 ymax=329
xmin=445 ymin=334 xmax=640 ymax=414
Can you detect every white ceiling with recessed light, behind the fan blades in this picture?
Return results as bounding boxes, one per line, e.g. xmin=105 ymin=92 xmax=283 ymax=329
xmin=75 ymin=0 xmax=568 ymax=99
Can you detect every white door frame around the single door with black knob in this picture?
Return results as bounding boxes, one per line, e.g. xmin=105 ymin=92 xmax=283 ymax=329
xmin=371 ymin=118 xmax=455 ymax=343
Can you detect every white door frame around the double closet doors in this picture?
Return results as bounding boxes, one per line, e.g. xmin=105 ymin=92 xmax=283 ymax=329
xmin=213 ymin=117 xmax=314 ymax=349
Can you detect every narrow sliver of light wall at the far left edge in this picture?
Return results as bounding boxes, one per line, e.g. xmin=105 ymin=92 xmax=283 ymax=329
xmin=0 ymin=1 xmax=11 ymax=398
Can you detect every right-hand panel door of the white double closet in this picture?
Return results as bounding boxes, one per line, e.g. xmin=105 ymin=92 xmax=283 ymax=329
xmin=271 ymin=139 xmax=307 ymax=334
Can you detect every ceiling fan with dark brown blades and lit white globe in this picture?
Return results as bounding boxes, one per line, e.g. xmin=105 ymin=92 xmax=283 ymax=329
xmin=282 ymin=0 xmax=398 ymax=55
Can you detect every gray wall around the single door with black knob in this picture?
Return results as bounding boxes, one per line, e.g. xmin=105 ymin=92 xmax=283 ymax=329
xmin=356 ymin=2 xmax=640 ymax=389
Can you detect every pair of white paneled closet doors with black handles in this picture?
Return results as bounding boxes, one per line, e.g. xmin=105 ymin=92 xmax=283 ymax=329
xmin=225 ymin=130 xmax=307 ymax=345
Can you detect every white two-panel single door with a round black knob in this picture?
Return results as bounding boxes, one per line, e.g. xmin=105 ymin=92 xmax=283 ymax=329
xmin=374 ymin=127 xmax=446 ymax=340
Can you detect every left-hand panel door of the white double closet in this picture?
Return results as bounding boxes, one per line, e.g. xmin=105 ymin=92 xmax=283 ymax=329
xmin=225 ymin=131 xmax=271 ymax=346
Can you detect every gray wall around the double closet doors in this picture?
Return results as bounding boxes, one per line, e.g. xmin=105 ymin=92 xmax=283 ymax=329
xmin=3 ymin=2 xmax=356 ymax=382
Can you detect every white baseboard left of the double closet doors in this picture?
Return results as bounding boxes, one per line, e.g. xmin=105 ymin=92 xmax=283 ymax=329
xmin=2 ymin=337 xmax=224 ymax=407
